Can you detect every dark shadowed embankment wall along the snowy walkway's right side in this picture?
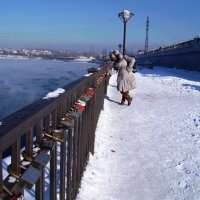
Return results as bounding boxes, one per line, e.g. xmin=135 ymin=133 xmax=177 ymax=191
xmin=136 ymin=37 xmax=200 ymax=71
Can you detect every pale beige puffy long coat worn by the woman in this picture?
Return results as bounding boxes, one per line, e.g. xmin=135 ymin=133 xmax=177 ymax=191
xmin=111 ymin=56 xmax=136 ymax=92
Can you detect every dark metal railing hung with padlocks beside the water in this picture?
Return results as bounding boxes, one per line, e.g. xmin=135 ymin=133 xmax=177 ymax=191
xmin=0 ymin=64 xmax=111 ymax=200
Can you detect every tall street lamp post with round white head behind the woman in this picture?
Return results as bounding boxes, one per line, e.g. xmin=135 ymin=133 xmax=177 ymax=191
xmin=118 ymin=10 xmax=134 ymax=55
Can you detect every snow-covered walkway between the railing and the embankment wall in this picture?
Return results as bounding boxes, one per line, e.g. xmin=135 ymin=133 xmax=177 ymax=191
xmin=77 ymin=67 xmax=200 ymax=200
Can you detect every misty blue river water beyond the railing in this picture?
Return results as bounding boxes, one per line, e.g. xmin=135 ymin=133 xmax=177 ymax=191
xmin=0 ymin=58 xmax=97 ymax=119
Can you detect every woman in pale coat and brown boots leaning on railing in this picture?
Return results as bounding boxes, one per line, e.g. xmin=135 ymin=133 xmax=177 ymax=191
xmin=110 ymin=50 xmax=136 ymax=106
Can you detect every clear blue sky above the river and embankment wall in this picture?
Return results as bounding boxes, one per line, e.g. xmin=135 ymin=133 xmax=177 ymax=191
xmin=0 ymin=0 xmax=200 ymax=51
